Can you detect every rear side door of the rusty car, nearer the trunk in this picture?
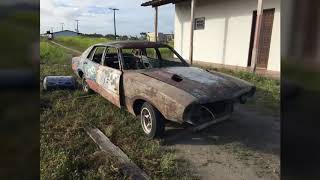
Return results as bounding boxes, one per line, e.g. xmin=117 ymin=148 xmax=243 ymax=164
xmin=83 ymin=46 xmax=106 ymax=92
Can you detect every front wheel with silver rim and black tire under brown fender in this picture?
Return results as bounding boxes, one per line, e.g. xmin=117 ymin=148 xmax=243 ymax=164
xmin=140 ymin=102 xmax=165 ymax=138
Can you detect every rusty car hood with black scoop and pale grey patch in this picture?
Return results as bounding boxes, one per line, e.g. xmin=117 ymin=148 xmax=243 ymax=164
xmin=141 ymin=67 xmax=253 ymax=101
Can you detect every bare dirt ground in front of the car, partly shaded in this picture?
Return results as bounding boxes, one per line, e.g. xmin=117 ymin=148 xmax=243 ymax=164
xmin=165 ymin=105 xmax=280 ymax=180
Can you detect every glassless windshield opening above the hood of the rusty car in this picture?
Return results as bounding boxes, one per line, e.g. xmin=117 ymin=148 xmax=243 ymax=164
xmin=121 ymin=47 xmax=188 ymax=70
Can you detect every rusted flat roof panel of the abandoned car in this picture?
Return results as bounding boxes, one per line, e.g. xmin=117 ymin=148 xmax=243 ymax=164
xmin=97 ymin=41 xmax=167 ymax=48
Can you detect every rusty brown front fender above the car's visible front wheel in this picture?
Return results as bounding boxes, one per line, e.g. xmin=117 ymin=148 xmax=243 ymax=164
xmin=123 ymin=73 xmax=195 ymax=123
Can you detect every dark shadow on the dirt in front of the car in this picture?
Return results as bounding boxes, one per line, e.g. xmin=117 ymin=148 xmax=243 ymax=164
xmin=164 ymin=105 xmax=280 ymax=155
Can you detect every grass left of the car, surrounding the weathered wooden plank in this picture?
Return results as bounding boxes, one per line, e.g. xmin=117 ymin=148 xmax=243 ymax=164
xmin=40 ymin=40 xmax=193 ymax=179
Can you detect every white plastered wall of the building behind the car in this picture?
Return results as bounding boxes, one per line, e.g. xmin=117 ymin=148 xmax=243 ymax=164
xmin=174 ymin=0 xmax=280 ymax=71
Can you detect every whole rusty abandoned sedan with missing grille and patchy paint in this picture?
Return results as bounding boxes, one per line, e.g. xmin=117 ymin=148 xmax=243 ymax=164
xmin=72 ymin=41 xmax=256 ymax=138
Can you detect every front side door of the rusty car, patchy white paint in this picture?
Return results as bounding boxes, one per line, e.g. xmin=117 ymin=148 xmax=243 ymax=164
xmin=97 ymin=47 xmax=122 ymax=107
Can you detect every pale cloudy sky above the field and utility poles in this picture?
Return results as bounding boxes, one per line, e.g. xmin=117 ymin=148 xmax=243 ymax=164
xmin=40 ymin=0 xmax=174 ymax=36
